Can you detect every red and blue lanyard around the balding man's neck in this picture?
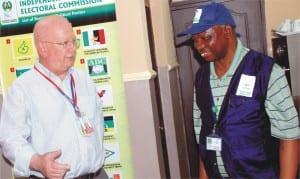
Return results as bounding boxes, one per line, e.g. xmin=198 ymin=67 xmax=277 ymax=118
xmin=34 ymin=66 xmax=80 ymax=116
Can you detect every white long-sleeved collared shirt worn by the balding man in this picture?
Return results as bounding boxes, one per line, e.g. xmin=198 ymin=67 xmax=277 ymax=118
xmin=0 ymin=61 xmax=104 ymax=178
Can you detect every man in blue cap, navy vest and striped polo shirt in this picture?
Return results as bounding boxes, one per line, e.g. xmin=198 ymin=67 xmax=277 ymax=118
xmin=178 ymin=3 xmax=300 ymax=179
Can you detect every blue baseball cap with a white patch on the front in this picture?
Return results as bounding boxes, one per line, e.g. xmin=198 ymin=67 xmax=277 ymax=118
xmin=177 ymin=2 xmax=236 ymax=36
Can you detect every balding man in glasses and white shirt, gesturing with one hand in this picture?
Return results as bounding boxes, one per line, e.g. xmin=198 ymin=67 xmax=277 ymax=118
xmin=0 ymin=15 xmax=107 ymax=179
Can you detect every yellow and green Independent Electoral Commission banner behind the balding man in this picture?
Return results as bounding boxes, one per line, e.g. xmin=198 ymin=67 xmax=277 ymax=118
xmin=0 ymin=0 xmax=134 ymax=179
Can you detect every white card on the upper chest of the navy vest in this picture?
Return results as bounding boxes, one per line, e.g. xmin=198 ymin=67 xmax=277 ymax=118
xmin=236 ymin=74 xmax=256 ymax=97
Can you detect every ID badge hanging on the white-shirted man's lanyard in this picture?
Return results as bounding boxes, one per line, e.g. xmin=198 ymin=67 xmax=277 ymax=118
xmin=77 ymin=113 xmax=94 ymax=136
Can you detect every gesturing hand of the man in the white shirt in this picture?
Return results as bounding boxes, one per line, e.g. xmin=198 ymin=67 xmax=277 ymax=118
xmin=30 ymin=150 xmax=70 ymax=179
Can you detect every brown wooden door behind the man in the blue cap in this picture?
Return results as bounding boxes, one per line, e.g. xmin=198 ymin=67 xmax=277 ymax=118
xmin=170 ymin=0 xmax=266 ymax=178
